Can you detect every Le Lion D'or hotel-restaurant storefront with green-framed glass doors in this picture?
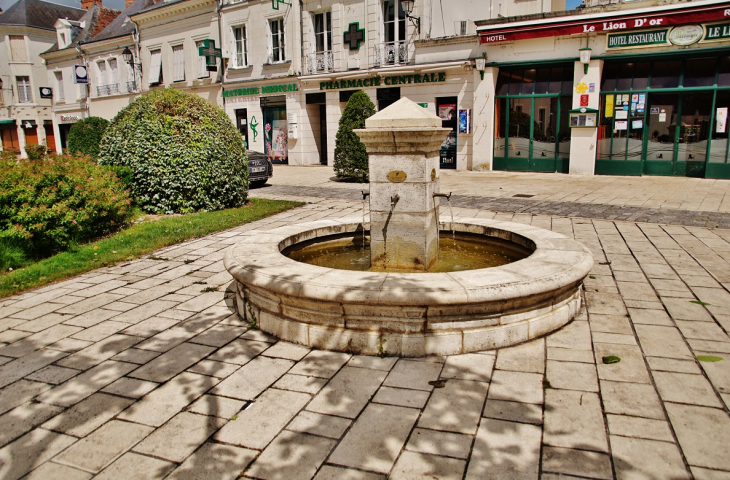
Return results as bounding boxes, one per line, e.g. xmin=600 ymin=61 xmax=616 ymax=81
xmin=478 ymin=1 xmax=730 ymax=178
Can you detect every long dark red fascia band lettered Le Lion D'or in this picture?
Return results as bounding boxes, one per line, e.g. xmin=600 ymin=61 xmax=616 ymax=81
xmin=479 ymin=3 xmax=730 ymax=43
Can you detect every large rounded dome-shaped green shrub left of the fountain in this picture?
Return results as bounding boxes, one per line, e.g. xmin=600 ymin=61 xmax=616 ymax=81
xmin=99 ymin=88 xmax=248 ymax=213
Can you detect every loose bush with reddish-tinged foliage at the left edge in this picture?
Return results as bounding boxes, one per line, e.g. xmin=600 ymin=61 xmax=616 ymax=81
xmin=0 ymin=156 xmax=132 ymax=257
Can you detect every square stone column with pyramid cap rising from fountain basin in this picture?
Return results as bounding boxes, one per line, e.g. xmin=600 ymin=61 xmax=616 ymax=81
xmin=355 ymin=97 xmax=450 ymax=272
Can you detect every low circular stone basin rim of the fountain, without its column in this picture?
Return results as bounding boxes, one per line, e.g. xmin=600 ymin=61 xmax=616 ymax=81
xmin=224 ymin=218 xmax=593 ymax=357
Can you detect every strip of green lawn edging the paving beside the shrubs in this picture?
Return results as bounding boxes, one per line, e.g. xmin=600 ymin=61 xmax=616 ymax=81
xmin=0 ymin=198 xmax=303 ymax=298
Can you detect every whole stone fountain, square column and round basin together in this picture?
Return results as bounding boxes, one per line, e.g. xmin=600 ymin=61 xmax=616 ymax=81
xmin=224 ymin=98 xmax=593 ymax=356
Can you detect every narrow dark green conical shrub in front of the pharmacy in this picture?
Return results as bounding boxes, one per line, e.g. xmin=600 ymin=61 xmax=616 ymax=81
xmin=334 ymin=91 xmax=375 ymax=182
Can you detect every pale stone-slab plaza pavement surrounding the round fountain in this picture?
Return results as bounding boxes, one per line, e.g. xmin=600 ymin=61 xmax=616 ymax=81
xmin=0 ymin=166 xmax=730 ymax=480
